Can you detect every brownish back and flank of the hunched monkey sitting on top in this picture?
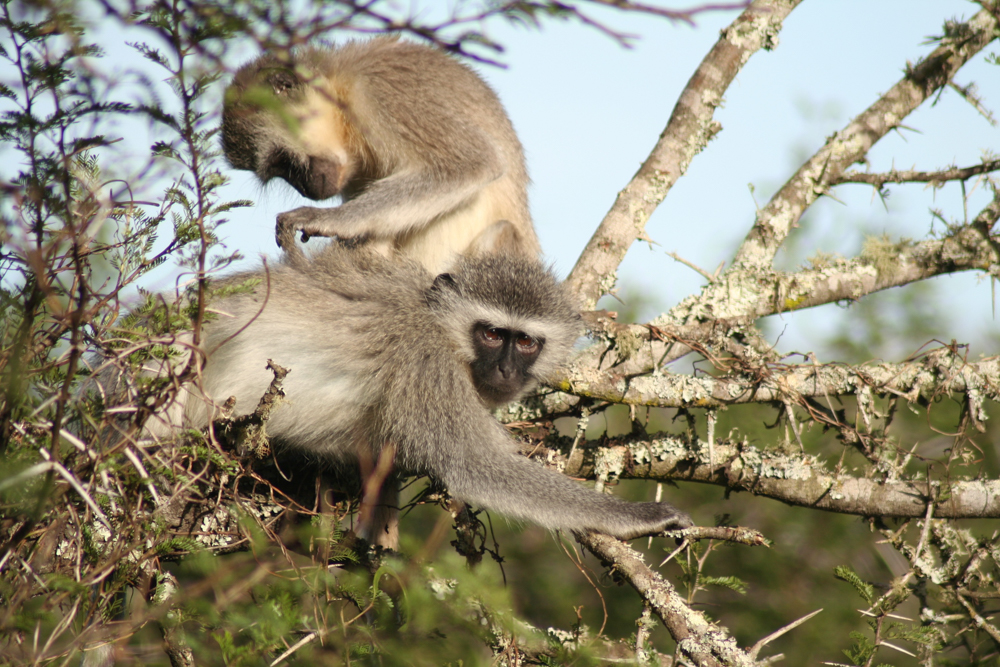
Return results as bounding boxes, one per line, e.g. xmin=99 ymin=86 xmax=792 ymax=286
xmin=318 ymin=37 xmax=540 ymax=266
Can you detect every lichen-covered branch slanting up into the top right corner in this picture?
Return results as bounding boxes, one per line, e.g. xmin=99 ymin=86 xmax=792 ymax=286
xmin=730 ymin=9 xmax=997 ymax=270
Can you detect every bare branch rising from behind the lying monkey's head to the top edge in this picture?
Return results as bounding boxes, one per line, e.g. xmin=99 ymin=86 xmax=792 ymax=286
xmin=567 ymin=0 xmax=801 ymax=309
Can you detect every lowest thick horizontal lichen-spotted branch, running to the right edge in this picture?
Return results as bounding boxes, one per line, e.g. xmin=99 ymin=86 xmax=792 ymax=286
xmin=548 ymin=433 xmax=1000 ymax=519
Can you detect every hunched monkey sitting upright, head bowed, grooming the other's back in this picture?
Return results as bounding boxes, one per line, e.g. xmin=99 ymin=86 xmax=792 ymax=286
xmin=222 ymin=37 xmax=540 ymax=275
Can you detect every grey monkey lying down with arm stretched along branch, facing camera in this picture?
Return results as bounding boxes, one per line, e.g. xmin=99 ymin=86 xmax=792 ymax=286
xmin=127 ymin=242 xmax=691 ymax=545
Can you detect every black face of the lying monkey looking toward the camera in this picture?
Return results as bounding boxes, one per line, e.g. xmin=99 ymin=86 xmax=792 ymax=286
xmin=472 ymin=322 xmax=545 ymax=406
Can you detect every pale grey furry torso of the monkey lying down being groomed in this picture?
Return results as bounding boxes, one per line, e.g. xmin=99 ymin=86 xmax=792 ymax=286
xmin=192 ymin=243 xmax=471 ymax=464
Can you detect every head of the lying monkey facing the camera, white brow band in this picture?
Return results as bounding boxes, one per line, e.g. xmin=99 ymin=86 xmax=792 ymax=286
xmin=428 ymin=253 xmax=582 ymax=407
